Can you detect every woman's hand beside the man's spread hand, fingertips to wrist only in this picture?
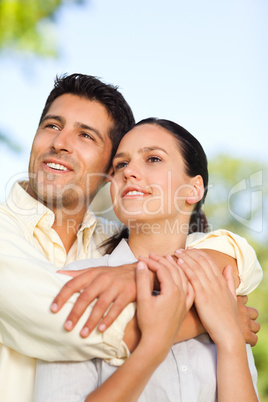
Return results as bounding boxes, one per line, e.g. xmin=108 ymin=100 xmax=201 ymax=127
xmin=136 ymin=256 xmax=194 ymax=356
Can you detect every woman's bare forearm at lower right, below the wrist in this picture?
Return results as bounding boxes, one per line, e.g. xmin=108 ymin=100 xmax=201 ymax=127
xmin=217 ymin=331 xmax=258 ymax=402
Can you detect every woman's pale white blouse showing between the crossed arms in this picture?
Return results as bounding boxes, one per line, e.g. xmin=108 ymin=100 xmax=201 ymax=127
xmin=34 ymin=240 xmax=257 ymax=402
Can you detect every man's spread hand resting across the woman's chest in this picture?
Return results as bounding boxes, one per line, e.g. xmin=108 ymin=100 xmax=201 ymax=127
xmin=51 ymin=263 xmax=137 ymax=338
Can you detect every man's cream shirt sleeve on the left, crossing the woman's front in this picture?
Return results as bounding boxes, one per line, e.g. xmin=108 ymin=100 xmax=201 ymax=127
xmin=0 ymin=212 xmax=135 ymax=361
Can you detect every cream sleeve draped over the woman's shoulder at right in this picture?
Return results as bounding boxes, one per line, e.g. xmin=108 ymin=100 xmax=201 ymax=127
xmin=186 ymin=229 xmax=263 ymax=295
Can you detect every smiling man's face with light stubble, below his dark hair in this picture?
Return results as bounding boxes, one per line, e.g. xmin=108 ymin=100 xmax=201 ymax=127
xmin=28 ymin=94 xmax=113 ymax=213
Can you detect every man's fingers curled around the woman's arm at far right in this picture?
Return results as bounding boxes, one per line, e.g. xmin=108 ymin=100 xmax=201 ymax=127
xmin=237 ymin=296 xmax=261 ymax=346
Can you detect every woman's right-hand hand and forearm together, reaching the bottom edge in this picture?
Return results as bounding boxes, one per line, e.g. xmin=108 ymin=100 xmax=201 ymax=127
xmin=177 ymin=249 xmax=258 ymax=402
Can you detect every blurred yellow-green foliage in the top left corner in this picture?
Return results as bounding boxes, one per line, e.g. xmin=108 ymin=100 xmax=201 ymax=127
xmin=0 ymin=0 xmax=83 ymax=57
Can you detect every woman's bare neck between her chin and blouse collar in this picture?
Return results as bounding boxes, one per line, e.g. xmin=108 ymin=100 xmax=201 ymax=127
xmin=128 ymin=220 xmax=188 ymax=258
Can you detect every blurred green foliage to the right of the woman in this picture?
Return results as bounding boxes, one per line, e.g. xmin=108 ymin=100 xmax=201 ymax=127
xmin=205 ymin=155 xmax=268 ymax=402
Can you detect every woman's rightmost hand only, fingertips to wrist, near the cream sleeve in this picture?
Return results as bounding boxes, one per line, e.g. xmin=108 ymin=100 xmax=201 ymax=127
xmin=177 ymin=249 xmax=241 ymax=344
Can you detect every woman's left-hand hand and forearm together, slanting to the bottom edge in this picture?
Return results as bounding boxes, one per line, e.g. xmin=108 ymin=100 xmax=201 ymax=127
xmin=86 ymin=257 xmax=194 ymax=402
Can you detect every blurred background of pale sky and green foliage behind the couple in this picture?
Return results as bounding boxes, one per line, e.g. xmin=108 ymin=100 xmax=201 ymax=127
xmin=0 ymin=0 xmax=268 ymax=401
